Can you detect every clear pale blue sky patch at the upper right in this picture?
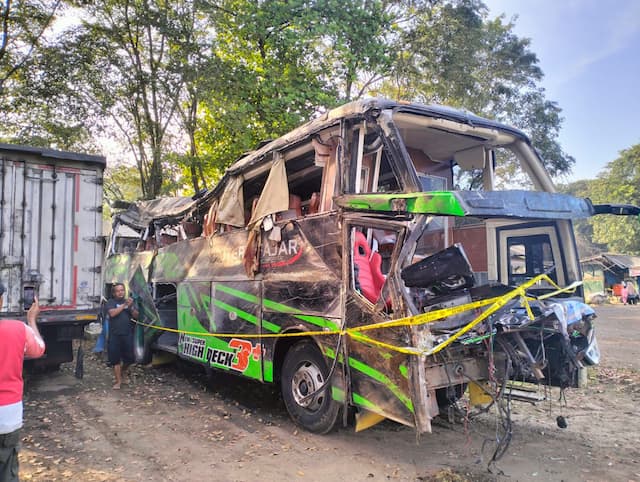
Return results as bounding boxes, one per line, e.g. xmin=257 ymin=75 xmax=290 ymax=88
xmin=484 ymin=0 xmax=640 ymax=181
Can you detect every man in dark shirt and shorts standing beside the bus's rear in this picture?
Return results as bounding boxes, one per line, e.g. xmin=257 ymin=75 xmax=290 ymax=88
xmin=107 ymin=283 xmax=138 ymax=390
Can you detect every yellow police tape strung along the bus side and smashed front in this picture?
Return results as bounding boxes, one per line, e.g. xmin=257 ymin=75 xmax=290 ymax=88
xmin=130 ymin=274 xmax=582 ymax=356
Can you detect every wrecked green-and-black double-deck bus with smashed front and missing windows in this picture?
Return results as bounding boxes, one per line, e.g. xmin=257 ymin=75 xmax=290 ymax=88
xmin=104 ymin=99 xmax=638 ymax=448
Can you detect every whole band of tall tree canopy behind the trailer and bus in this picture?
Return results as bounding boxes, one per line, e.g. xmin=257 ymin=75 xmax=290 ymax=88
xmin=0 ymin=0 xmax=574 ymax=198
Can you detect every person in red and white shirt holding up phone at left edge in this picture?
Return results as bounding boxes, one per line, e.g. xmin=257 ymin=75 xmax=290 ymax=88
xmin=0 ymin=285 xmax=45 ymax=482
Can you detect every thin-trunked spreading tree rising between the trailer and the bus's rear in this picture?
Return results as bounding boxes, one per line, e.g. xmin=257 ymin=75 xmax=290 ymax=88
xmin=64 ymin=0 xmax=202 ymax=198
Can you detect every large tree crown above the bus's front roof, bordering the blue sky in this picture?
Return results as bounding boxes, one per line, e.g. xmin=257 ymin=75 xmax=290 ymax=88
xmin=380 ymin=0 xmax=575 ymax=177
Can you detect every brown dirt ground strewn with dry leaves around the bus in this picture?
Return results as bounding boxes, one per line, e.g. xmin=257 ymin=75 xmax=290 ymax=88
xmin=20 ymin=306 xmax=640 ymax=482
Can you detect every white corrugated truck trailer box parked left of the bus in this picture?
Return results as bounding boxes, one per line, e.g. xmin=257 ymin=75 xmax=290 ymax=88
xmin=0 ymin=144 xmax=106 ymax=368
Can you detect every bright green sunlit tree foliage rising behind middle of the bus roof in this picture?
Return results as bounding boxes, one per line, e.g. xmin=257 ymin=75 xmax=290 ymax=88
xmin=197 ymin=0 xmax=336 ymax=173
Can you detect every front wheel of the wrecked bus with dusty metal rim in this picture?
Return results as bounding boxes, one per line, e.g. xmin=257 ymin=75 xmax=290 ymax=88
xmin=280 ymin=342 xmax=340 ymax=434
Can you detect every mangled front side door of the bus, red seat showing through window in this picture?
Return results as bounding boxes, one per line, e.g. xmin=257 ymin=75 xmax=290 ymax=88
xmin=344 ymin=220 xmax=415 ymax=425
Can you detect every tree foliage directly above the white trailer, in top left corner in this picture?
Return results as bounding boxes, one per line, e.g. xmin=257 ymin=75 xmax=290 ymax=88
xmin=0 ymin=0 xmax=95 ymax=151
